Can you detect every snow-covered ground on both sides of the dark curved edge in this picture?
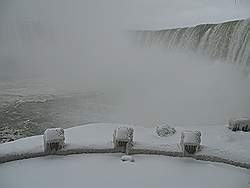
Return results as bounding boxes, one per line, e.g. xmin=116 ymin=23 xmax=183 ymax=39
xmin=0 ymin=124 xmax=250 ymax=188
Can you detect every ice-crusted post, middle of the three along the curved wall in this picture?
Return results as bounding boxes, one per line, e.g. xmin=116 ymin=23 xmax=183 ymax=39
xmin=113 ymin=127 xmax=134 ymax=154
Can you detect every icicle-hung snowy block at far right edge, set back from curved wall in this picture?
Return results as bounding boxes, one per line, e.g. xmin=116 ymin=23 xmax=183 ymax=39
xmin=228 ymin=117 xmax=250 ymax=131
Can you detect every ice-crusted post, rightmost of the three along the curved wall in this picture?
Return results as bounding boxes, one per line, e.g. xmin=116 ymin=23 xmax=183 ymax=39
xmin=180 ymin=131 xmax=201 ymax=156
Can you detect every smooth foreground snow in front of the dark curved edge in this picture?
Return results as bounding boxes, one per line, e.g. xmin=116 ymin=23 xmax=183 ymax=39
xmin=0 ymin=154 xmax=250 ymax=188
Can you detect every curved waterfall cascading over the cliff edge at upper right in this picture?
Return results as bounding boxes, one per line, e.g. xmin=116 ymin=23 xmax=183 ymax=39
xmin=136 ymin=19 xmax=250 ymax=66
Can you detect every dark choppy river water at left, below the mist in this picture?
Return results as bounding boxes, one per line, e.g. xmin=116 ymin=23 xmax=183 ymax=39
xmin=0 ymin=82 xmax=118 ymax=143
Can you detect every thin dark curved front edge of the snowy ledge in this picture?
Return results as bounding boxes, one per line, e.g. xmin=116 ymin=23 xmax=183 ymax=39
xmin=0 ymin=148 xmax=250 ymax=169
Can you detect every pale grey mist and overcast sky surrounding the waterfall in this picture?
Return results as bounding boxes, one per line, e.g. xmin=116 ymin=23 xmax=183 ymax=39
xmin=0 ymin=0 xmax=250 ymax=126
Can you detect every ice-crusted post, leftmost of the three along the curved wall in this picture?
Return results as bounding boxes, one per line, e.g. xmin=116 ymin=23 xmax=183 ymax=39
xmin=43 ymin=128 xmax=65 ymax=153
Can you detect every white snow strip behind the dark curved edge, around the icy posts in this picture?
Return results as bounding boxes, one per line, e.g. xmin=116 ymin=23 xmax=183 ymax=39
xmin=0 ymin=123 xmax=250 ymax=164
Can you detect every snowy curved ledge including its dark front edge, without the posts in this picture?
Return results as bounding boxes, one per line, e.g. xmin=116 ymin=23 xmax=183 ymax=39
xmin=0 ymin=124 xmax=250 ymax=169
